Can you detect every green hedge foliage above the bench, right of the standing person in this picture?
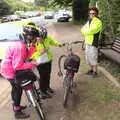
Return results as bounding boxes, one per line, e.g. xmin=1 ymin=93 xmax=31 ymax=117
xmin=90 ymin=0 xmax=120 ymax=38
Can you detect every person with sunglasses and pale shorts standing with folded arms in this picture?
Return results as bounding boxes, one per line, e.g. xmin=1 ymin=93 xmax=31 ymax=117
xmin=81 ymin=7 xmax=102 ymax=77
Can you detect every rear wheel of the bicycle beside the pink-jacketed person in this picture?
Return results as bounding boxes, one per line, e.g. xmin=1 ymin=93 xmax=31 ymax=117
xmin=26 ymin=89 xmax=46 ymax=120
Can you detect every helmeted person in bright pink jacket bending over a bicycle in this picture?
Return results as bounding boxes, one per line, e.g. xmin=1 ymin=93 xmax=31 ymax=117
xmin=0 ymin=24 xmax=39 ymax=119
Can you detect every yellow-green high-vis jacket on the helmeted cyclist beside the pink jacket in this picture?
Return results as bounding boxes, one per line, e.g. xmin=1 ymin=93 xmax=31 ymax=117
xmin=31 ymin=36 xmax=61 ymax=61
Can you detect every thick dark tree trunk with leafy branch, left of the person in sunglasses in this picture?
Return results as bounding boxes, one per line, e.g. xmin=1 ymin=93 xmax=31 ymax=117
xmin=52 ymin=0 xmax=89 ymax=22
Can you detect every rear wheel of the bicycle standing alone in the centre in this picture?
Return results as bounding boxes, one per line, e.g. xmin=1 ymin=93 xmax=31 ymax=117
xmin=63 ymin=77 xmax=71 ymax=108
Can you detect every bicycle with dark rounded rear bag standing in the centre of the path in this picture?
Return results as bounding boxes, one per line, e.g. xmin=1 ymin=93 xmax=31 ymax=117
xmin=58 ymin=41 xmax=83 ymax=108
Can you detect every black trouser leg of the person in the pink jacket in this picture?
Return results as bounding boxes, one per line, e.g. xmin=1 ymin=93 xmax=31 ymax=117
xmin=9 ymin=80 xmax=22 ymax=106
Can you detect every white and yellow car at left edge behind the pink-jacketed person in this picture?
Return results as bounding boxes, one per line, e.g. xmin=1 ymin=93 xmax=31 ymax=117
xmin=0 ymin=22 xmax=23 ymax=61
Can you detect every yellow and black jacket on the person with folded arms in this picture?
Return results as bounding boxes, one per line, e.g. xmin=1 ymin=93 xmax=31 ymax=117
xmin=81 ymin=17 xmax=102 ymax=47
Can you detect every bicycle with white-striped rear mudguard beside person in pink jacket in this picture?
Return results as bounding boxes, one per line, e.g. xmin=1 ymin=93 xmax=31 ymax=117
xmin=17 ymin=68 xmax=46 ymax=120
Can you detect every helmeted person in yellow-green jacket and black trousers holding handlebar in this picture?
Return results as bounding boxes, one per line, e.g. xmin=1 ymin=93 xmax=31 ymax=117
xmin=30 ymin=24 xmax=62 ymax=99
